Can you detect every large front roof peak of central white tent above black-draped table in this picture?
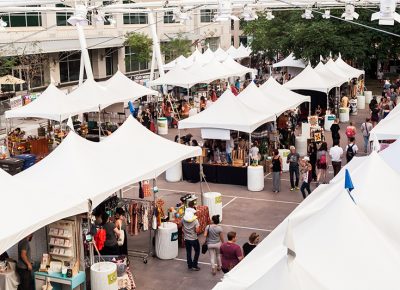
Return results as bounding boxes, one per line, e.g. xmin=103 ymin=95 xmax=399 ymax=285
xmin=178 ymin=90 xmax=269 ymax=133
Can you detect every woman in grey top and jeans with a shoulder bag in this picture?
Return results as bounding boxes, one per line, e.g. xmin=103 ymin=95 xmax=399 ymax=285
xmin=204 ymin=215 xmax=224 ymax=275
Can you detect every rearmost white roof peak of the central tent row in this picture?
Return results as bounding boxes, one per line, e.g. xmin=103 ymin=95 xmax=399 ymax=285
xmin=260 ymin=77 xmax=310 ymax=109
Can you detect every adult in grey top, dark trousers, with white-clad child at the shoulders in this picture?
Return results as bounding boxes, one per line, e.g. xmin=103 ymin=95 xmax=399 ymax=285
xmin=181 ymin=201 xmax=200 ymax=271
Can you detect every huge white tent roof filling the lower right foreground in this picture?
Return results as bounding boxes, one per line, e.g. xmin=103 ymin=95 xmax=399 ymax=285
xmin=214 ymin=153 xmax=400 ymax=290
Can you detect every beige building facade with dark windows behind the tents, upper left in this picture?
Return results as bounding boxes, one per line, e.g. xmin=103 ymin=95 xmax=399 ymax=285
xmin=0 ymin=1 xmax=236 ymax=91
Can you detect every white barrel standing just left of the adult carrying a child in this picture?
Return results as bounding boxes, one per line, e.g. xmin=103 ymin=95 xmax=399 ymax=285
xmin=155 ymin=222 xmax=178 ymax=260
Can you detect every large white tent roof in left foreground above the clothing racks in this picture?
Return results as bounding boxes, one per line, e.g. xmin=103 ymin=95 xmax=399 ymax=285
xmin=0 ymin=117 xmax=201 ymax=252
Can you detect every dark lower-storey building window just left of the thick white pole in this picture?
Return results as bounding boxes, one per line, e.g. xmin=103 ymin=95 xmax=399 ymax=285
xmin=59 ymin=51 xmax=81 ymax=83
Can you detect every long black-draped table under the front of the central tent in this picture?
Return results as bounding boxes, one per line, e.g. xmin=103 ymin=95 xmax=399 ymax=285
xmin=182 ymin=161 xmax=247 ymax=185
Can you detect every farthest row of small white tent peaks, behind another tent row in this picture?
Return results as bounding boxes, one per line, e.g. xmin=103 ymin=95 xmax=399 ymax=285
xmin=164 ymin=44 xmax=251 ymax=70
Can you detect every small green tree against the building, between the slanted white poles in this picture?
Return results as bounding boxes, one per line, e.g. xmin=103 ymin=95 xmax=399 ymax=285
xmin=124 ymin=32 xmax=153 ymax=62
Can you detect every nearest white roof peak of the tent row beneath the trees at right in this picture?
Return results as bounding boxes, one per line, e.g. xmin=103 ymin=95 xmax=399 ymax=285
xmin=283 ymin=65 xmax=333 ymax=93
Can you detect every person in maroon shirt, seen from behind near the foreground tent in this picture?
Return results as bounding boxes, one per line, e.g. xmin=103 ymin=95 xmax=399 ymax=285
xmin=220 ymin=232 xmax=243 ymax=273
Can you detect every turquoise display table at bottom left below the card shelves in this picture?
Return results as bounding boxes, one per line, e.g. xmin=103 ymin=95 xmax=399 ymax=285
xmin=34 ymin=271 xmax=86 ymax=290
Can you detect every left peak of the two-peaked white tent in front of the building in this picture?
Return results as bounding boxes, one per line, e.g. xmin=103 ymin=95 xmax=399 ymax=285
xmin=5 ymin=84 xmax=67 ymax=122
